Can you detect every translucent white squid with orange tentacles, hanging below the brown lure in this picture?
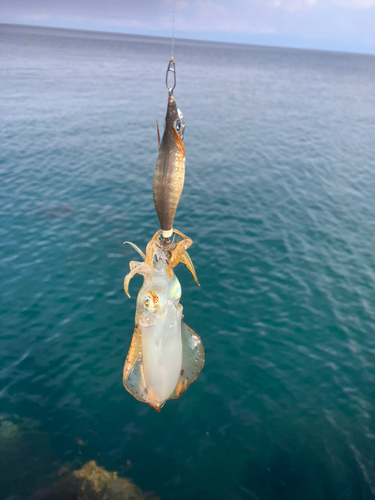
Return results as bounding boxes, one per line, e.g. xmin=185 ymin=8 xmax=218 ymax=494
xmin=123 ymin=230 xmax=204 ymax=411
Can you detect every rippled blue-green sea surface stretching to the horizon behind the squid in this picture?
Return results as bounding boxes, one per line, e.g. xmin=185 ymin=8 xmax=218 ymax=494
xmin=0 ymin=25 xmax=375 ymax=500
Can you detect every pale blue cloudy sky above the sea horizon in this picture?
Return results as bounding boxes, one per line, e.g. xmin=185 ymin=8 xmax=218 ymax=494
xmin=0 ymin=0 xmax=375 ymax=54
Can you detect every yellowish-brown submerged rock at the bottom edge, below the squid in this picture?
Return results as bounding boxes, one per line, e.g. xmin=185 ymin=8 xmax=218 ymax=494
xmin=33 ymin=460 xmax=158 ymax=500
